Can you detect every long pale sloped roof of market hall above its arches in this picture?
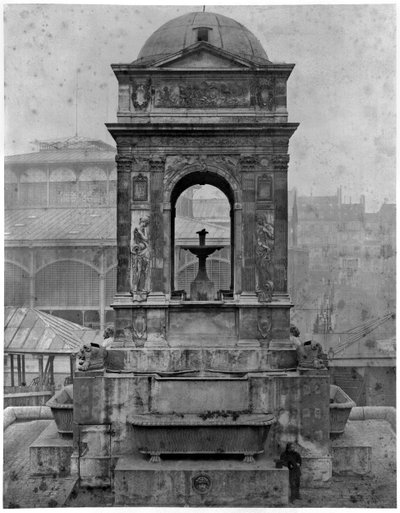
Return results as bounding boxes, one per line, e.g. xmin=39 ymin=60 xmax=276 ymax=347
xmin=4 ymin=207 xmax=117 ymax=245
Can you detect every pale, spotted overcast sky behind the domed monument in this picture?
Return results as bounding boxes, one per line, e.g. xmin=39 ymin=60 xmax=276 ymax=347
xmin=4 ymin=4 xmax=396 ymax=211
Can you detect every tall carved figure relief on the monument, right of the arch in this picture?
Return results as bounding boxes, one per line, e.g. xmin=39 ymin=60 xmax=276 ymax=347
xmin=256 ymin=214 xmax=275 ymax=302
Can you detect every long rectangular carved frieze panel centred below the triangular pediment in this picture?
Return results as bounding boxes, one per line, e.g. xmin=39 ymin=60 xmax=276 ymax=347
xmin=155 ymin=80 xmax=250 ymax=109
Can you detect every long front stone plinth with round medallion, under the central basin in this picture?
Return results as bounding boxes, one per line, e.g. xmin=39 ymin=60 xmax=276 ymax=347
xmin=114 ymin=456 xmax=289 ymax=507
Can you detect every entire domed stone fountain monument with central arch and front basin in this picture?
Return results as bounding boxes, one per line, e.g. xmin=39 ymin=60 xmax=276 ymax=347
xmin=68 ymin=12 xmax=331 ymax=507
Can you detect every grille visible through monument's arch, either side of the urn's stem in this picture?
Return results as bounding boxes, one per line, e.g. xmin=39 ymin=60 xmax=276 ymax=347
xmin=176 ymin=258 xmax=231 ymax=295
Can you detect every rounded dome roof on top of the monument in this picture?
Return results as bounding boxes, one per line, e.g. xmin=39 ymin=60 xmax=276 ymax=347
xmin=136 ymin=12 xmax=268 ymax=64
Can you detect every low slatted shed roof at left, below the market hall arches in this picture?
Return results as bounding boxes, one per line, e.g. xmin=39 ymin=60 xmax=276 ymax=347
xmin=4 ymin=306 xmax=103 ymax=354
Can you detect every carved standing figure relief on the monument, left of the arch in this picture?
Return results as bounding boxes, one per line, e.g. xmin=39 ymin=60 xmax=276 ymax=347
xmin=131 ymin=217 xmax=150 ymax=294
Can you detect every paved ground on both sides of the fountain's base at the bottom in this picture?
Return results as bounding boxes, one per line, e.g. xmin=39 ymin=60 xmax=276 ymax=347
xmin=3 ymin=420 xmax=396 ymax=511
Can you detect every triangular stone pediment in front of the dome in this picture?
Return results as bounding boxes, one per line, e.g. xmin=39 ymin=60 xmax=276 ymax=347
xmin=148 ymin=42 xmax=254 ymax=69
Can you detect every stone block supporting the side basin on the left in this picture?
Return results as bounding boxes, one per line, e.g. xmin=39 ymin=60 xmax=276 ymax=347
xmin=29 ymin=422 xmax=73 ymax=477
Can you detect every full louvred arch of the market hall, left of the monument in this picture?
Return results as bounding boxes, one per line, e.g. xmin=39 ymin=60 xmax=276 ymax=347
xmin=35 ymin=261 xmax=99 ymax=306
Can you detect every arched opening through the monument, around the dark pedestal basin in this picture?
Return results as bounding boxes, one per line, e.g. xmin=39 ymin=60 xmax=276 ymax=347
xmin=171 ymin=172 xmax=234 ymax=300
